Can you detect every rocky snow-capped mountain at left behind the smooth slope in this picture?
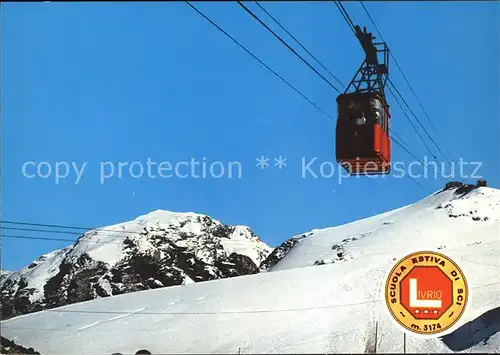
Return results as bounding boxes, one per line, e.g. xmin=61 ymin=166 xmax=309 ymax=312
xmin=0 ymin=210 xmax=272 ymax=318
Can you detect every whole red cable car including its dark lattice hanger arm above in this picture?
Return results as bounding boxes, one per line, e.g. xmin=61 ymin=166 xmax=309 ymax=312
xmin=336 ymin=26 xmax=391 ymax=175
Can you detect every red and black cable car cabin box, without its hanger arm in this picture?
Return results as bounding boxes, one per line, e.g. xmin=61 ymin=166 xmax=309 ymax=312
xmin=336 ymin=92 xmax=391 ymax=175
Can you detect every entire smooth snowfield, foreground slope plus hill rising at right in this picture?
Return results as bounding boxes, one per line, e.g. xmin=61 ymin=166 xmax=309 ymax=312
xmin=1 ymin=184 xmax=500 ymax=355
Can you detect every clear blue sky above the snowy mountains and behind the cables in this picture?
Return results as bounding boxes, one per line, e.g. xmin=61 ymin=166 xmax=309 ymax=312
xmin=1 ymin=2 xmax=500 ymax=269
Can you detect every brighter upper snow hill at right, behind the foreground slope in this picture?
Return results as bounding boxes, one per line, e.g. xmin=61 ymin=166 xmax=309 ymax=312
xmin=269 ymin=187 xmax=500 ymax=271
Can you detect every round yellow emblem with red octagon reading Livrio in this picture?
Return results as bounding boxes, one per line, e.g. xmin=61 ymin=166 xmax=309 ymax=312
xmin=385 ymin=251 xmax=469 ymax=335
